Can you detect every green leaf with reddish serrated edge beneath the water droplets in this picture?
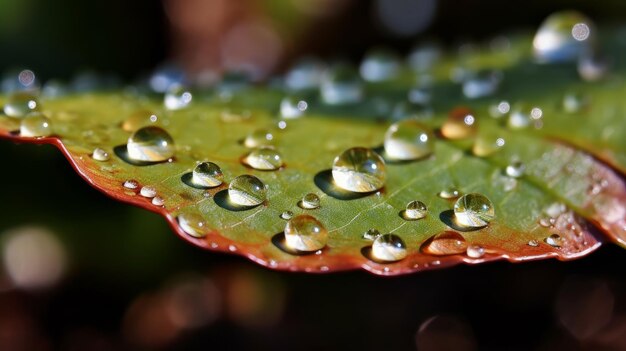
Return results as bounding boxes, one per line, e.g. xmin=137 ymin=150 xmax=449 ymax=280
xmin=0 ymin=32 xmax=626 ymax=275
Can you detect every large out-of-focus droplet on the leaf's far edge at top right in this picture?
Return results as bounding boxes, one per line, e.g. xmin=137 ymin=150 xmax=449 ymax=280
xmin=533 ymin=11 xmax=595 ymax=63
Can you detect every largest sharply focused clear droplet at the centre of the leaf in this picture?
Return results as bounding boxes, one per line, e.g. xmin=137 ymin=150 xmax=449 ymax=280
xmin=332 ymin=147 xmax=387 ymax=193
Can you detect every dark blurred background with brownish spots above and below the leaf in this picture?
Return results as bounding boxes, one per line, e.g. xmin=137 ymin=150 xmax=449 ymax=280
xmin=0 ymin=0 xmax=626 ymax=351
